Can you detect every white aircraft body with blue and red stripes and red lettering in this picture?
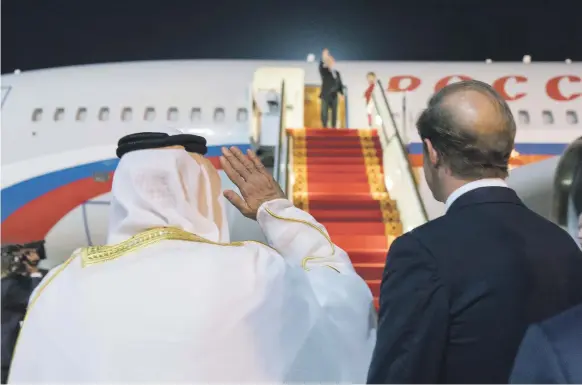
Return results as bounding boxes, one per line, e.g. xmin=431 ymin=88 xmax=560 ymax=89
xmin=2 ymin=60 xmax=582 ymax=266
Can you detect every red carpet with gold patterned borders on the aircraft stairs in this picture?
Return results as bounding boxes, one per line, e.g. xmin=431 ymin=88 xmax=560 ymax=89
xmin=288 ymin=129 xmax=402 ymax=306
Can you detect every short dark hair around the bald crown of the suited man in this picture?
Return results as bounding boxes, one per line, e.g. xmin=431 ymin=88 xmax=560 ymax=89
xmin=416 ymin=80 xmax=515 ymax=179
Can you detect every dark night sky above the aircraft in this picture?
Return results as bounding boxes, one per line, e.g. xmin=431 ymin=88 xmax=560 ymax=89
xmin=2 ymin=0 xmax=582 ymax=73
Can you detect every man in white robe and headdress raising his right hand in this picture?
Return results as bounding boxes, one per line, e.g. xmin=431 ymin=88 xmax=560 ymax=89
xmin=9 ymin=133 xmax=376 ymax=383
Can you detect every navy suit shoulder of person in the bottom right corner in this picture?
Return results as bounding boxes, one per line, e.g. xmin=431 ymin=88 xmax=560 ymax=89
xmin=511 ymin=305 xmax=582 ymax=384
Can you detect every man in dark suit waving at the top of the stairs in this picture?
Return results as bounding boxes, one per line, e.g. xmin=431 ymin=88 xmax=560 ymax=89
xmin=319 ymin=49 xmax=344 ymax=128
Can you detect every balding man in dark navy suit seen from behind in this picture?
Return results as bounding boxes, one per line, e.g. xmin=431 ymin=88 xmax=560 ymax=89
xmin=368 ymin=80 xmax=582 ymax=383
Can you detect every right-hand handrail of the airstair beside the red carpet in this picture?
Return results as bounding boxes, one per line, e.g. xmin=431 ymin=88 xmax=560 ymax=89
xmin=372 ymin=80 xmax=428 ymax=226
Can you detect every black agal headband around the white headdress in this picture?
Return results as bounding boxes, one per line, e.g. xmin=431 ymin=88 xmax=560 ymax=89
xmin=116 ymin=132 xmax=208 ymax=159
